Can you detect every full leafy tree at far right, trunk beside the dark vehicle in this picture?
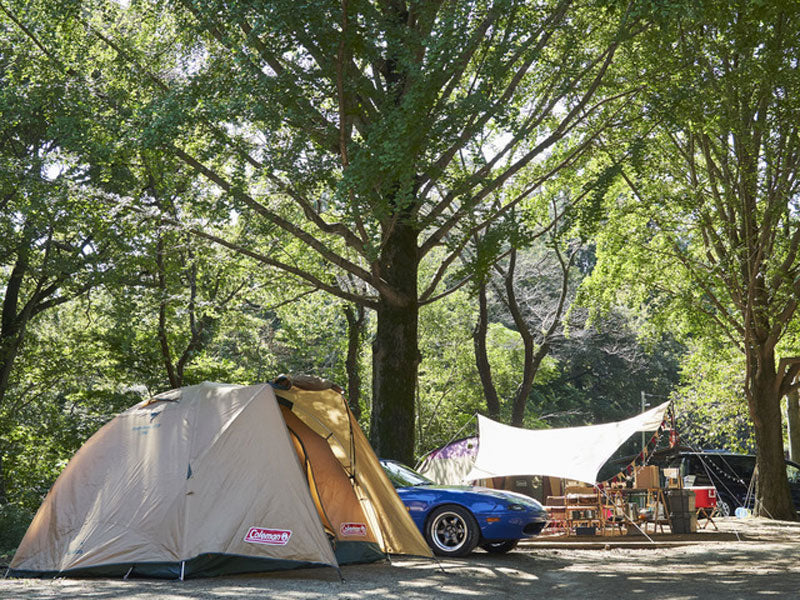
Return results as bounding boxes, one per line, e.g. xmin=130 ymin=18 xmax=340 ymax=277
xmin=587 ymin=1 xmax=800 ymax=518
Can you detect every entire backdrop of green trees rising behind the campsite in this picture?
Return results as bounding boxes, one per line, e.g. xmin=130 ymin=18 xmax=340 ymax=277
xmin=0 ymin=0 xmax=800 ymax=544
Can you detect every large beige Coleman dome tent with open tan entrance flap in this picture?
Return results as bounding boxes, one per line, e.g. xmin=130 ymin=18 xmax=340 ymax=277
xmin=10 ymin=378 xmax=430 ymax=578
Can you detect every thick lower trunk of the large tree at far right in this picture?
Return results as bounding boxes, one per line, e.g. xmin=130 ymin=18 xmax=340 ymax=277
xmin=748 ymin=349 xmax=797 ymax=521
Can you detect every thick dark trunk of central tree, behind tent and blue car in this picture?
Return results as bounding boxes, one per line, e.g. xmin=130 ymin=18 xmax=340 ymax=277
xmin=370 ymin=219 xmax=420 ymax=464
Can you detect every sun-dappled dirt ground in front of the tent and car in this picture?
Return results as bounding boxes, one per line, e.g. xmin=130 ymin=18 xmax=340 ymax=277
xmin=0 ymin=518 xmax=800 ymax=600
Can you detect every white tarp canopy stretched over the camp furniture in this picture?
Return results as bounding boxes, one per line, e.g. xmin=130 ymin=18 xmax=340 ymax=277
xmin=466 ymin=402 xmax=669 ymax=483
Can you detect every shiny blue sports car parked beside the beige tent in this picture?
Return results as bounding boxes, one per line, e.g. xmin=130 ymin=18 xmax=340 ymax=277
xmin=381 ymin=460 xmax=547 ymax=556
